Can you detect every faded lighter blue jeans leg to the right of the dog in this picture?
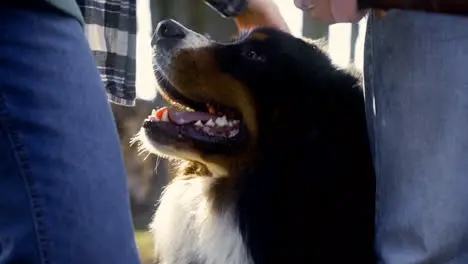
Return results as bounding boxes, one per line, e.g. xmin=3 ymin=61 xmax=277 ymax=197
xmin=364 ymin=11 xmax=468 ymax=264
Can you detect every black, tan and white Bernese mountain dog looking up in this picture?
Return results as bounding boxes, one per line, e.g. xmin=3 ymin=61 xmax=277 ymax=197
xmin=135 ymin=20 xmax=376 ymax=264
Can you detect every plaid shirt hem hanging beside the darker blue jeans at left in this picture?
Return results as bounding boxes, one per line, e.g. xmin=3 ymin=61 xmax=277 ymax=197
xmin=77 ymin=0 xmax=137 ymax=106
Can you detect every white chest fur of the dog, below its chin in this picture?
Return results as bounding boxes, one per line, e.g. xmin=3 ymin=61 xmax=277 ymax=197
xmin=151 ymin=177 xmax=253 ymax=264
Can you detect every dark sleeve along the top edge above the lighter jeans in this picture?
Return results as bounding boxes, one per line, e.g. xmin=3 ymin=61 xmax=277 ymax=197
xmin=358 ymin=0 xmax=468 ymax=15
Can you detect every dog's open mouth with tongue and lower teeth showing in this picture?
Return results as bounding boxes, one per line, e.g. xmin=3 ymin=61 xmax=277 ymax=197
xmin=143 ymin=70 xmax=247 ymax=154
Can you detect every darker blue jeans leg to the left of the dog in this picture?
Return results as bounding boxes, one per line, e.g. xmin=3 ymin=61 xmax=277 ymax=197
xmin=0 ymin=5 xmax=139 ymax=264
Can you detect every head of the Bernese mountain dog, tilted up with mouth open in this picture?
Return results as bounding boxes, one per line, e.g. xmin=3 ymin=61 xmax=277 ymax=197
xmin=139 ymin=20 xmax=358 ymax=175
